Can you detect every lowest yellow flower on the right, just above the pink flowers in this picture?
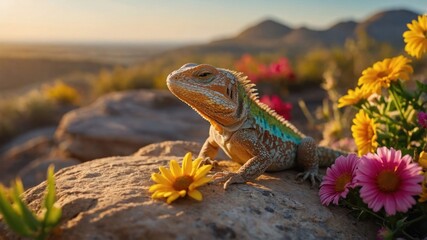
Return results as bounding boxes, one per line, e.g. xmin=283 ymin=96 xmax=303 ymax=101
xmin=351 ymin=110 xmax=378 ymax=156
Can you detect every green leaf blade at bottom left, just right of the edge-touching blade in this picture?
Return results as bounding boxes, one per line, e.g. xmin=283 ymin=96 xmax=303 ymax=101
xmin=12 ymin=179 xmax=41 ymax=232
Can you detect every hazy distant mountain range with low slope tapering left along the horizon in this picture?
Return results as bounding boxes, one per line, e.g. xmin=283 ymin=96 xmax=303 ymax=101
xmin=156 ymin=9 xmax=419 ymax=60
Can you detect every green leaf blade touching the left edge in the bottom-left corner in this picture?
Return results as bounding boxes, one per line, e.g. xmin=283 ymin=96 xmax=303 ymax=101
xmin=0 ymin=185 xmax=33 ymax=237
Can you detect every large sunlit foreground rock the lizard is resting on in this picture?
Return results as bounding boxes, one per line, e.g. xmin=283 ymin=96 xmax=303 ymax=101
xmin=0 ymin=143 xmax=376 ymax=240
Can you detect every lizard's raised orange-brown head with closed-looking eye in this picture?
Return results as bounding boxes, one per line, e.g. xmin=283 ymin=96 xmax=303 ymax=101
xmin=167 ymin=63 xmax=244 ymax=126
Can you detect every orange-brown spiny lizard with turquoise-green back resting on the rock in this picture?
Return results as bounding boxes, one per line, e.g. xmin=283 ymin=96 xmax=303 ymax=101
xmin=166 ymin=63 xmax=347 ymax=189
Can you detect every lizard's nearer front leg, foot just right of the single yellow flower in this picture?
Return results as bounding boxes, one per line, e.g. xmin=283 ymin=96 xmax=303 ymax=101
xmin=213 ymin=129 xmax=271 ymax=189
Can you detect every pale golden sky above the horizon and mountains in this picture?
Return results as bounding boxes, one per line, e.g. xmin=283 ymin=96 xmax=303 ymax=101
xmin=0 ymin=0 xmax=427 ymax=43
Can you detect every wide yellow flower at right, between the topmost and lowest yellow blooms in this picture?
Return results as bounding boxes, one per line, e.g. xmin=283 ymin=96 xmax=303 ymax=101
xmin=358 ymin=55 xmax=413 ymax=93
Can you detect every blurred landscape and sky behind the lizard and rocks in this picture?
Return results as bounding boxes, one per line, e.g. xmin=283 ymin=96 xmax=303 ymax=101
xmin=0 ymin=0 xmax=427 ymax=186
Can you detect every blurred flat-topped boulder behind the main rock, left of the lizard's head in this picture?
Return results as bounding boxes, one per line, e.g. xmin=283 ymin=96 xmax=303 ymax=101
xmin=56 ymin=90 xmax=209 ymax=160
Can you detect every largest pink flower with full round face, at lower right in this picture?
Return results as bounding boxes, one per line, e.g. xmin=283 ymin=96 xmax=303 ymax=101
xmin=356 ymin=147 xmax=423 ymax=215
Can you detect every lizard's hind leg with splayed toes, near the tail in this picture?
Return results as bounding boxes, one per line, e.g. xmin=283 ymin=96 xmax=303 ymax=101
xmin=296 ymin=137 xmax=322 ymax=186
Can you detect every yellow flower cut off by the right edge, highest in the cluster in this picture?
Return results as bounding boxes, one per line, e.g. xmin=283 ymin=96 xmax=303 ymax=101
xmin=403 ymin=15 xmax=427 ymax=58
